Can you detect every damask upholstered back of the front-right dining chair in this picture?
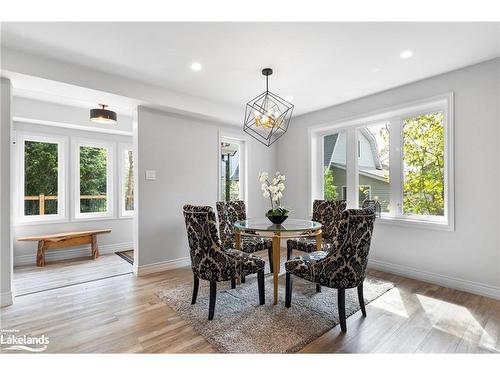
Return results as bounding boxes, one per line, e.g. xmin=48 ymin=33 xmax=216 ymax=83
xmin=315 ymin=207 xmax=375 ymax=288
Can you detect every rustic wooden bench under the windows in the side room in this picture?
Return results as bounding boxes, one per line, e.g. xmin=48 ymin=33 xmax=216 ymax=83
xmin=17 ymin=229 xmax=111 ymax=267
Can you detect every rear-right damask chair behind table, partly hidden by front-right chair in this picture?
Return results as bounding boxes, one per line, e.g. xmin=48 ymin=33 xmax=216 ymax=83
xmin=286 ymin=200 xmax=346 ymax=260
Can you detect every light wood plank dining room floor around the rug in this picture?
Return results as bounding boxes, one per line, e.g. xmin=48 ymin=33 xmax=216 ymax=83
xmin=1 ymin=251 xmax=500 ymax=353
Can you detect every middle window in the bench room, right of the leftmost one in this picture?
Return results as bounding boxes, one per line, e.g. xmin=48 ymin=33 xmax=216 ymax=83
xmin=74 ymin=140 xmax=113 ymax=219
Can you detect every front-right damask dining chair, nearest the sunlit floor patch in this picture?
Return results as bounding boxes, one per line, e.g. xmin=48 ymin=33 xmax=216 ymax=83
xmin=285 ymin=207 xmax=375 ymax=332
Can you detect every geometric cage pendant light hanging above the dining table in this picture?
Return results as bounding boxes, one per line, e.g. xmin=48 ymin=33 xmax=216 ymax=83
xmin=243 ymin=68 xmax=293 ymax=147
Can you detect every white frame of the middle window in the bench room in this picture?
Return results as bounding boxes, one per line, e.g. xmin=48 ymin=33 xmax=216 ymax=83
xmin=71 ymin=138 xmax=115 ymax=221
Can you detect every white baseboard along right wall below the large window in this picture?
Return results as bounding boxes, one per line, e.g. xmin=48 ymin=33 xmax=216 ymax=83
xmin=368 ymin=259 xmax=500 ymax=300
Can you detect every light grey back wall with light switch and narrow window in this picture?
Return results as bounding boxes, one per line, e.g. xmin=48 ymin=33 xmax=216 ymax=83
xmin=136 ymin=107 xmax=276 ymax=273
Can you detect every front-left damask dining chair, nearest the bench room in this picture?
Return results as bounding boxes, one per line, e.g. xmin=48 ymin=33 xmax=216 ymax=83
xmin=183 ymin=204 xmax=266 ymax=320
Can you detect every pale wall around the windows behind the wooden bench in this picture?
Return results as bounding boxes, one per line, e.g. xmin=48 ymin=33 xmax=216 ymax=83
xmin=13 ymin=98 xmax=133 ymax=265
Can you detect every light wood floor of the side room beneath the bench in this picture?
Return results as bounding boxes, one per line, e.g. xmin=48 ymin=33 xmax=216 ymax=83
xmin=14 ymin=254 xmax=132 ymax=296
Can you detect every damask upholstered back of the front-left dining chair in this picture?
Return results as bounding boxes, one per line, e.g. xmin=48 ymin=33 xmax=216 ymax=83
xmin=183 ymin=204 xmax=236 ymax=281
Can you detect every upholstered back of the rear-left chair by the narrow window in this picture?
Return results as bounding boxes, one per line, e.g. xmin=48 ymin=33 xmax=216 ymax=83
xmin=216 ymin=201 xmax=247 ymax=249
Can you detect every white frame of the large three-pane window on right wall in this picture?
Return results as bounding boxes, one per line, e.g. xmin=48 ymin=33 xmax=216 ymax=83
xmin=308 ymin=92 xmax=455 ymax=231
